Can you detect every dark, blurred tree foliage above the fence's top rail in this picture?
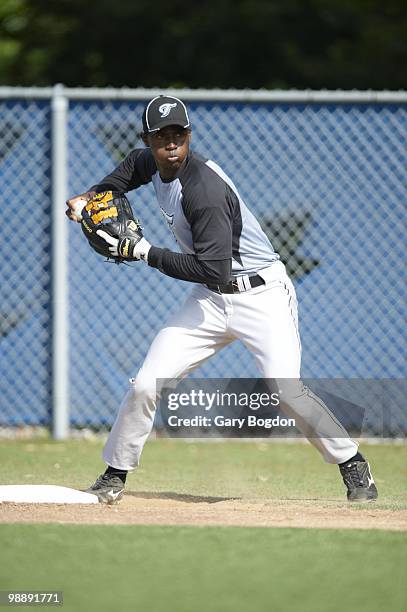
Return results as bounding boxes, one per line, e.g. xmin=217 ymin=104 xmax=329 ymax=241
xmin=0 ymin=0 xmax=407 ymax=89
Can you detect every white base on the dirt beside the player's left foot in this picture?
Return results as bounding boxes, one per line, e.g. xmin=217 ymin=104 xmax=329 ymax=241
xmin=0 ymin=485 xmax=99 ymax=504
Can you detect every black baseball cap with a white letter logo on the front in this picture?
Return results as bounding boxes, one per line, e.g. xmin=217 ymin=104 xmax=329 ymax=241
xmin=142 ymin=96 xmax=190 ymax=134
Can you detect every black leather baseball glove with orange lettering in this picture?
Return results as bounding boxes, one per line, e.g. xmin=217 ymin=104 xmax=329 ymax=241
xmin=81 ymin=191 xmax=143 ymax=263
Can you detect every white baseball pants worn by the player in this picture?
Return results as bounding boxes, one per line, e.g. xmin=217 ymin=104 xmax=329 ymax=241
xmin=103 ymin=261 xmax=358 ymax=470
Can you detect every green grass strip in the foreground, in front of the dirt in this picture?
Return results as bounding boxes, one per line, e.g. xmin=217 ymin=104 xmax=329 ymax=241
xmin=0 ymin=525 xmax=407 ymax=612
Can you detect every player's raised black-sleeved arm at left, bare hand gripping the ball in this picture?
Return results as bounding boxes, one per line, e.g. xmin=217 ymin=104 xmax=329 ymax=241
xmin=65 ymin=149 xmax=156 ymax=223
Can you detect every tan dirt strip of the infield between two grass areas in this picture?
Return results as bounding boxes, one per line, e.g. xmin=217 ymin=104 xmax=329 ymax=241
xmin=0 ymin=492 xmax=407 ymax=531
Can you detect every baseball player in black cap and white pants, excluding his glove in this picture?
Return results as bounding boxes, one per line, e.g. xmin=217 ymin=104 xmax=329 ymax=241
xmin=66 ymin=96 xmax=377 ymax=503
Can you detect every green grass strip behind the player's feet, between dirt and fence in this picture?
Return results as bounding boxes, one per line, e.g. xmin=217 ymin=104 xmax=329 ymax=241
xmin=0 ymin=439 xmax=407 ymax=509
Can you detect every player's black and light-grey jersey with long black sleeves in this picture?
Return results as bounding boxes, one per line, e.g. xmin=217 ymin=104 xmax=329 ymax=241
xmin=90 ymin=148 xmax=279 ymax=284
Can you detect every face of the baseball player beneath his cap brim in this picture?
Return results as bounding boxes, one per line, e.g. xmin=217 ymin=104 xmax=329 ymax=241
xmin=144 ymin=125 xmax=191 ymax=179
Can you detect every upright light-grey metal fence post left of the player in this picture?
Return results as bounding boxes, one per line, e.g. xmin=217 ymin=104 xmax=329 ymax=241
xmin=51 ymin=84 xmax=69 ymax=440
